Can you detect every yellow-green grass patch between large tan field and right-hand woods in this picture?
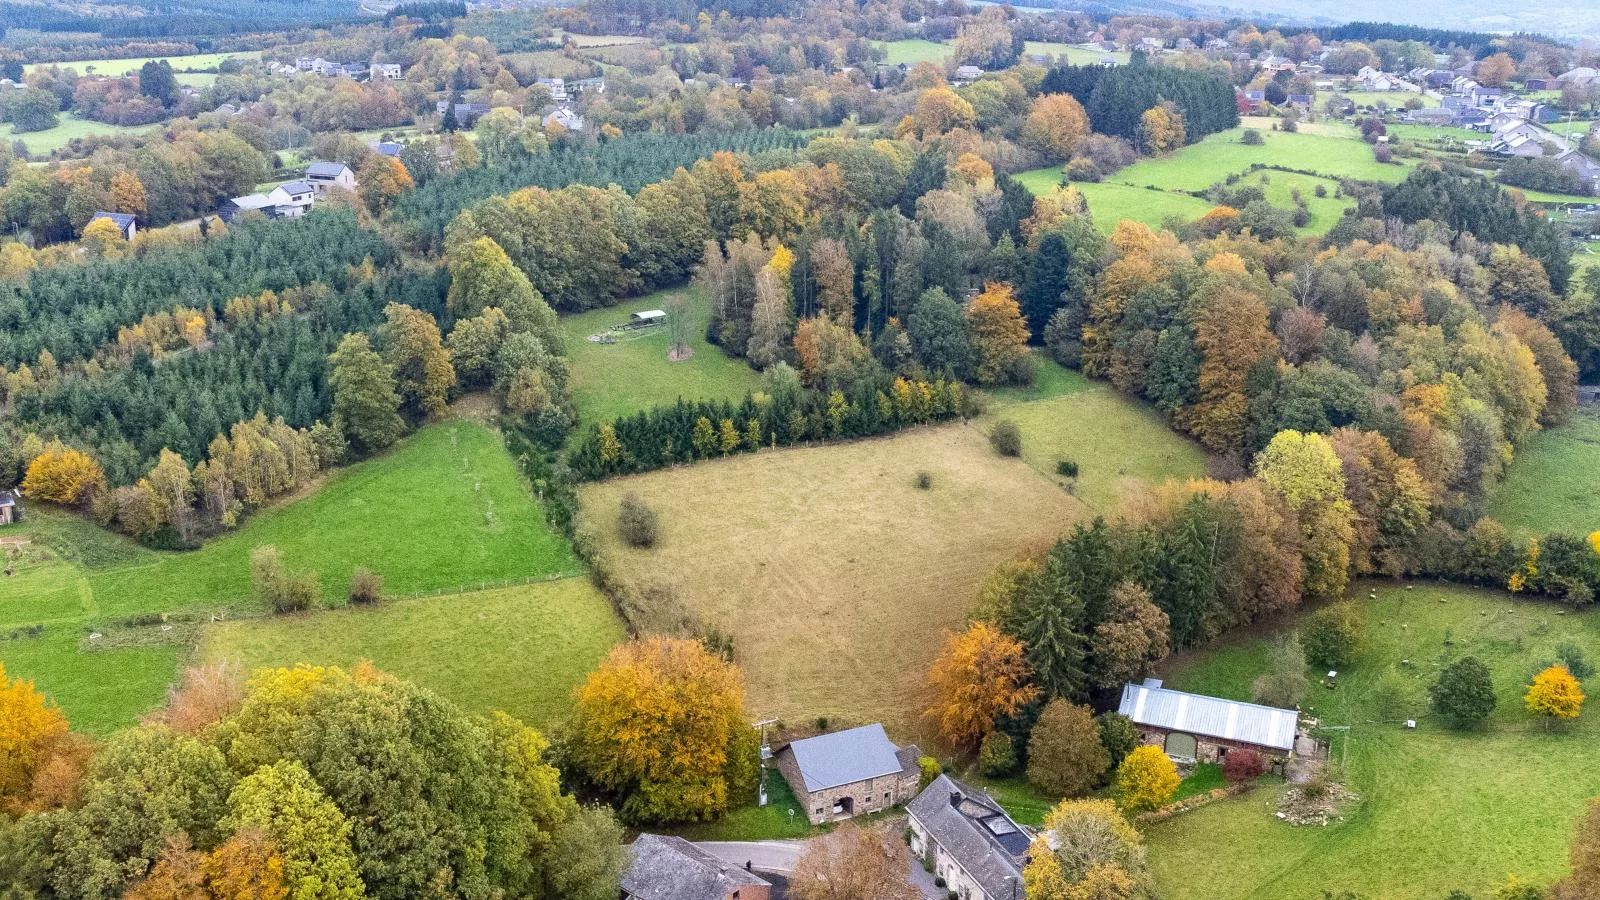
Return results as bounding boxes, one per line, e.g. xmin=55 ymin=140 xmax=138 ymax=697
xmin=978 ymin=376 xmax=1205 ymax=517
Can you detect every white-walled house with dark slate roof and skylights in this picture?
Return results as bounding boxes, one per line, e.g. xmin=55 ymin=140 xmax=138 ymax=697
xmin=906 ymin=775 xmax=1034 ymax=900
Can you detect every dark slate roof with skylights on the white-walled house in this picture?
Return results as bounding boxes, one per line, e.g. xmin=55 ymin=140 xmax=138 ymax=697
xmin=906 ymin=775 xmax=1032 ymax=900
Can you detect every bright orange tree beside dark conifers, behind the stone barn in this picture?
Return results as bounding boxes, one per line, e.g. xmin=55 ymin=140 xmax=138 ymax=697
xmin=926 ymin=621 xmax=1038 ymax=749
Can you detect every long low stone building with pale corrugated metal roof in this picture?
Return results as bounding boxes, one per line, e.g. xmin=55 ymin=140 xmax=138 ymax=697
xmin=1117 ymin=677 xmax=1301 ymax=767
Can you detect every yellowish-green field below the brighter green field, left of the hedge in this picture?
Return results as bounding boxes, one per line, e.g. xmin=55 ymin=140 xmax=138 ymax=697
xmin=198 ymin=578 xmax=626 ymax=727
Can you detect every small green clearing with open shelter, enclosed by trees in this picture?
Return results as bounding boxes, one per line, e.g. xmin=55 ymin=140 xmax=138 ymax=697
xmin=562 ymin=288 xmax=760 ymax=423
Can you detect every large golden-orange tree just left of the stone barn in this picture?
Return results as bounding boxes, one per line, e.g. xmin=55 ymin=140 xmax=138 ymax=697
xmin=571 ymin=637 xmax=757 ymax=823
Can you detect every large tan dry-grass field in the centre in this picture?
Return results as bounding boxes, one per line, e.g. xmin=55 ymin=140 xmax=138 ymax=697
xmin=581 ymin=423 xmax=1088 ymax=748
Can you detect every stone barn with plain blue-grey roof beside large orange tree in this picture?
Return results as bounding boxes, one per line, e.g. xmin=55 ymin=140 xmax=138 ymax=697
xmin=776 ymin=722 xmax=922 ymax=825
